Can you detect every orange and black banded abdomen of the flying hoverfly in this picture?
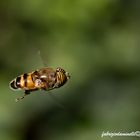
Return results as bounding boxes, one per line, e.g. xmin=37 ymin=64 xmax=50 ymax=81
xmin=10 ymin=73 xmax=36 ymax=90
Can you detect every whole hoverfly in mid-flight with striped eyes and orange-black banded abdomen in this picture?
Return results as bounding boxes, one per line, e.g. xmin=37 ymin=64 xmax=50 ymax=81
xmin=10 ymin=67 xmax=70 ymax=101
